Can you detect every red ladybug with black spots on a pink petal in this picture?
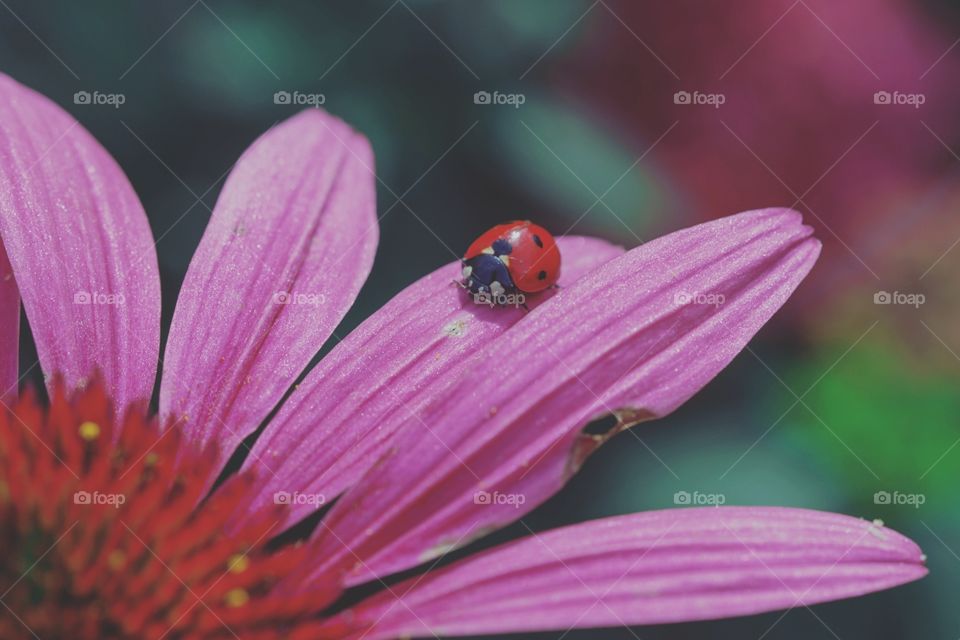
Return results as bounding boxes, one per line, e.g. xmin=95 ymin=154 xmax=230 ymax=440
xmin=460 ymin=220 xmax=560 ymax=305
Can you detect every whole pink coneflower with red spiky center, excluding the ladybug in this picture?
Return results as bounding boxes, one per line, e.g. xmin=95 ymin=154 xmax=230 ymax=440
xmin=0 ymin=77 xmax=926 ymax=638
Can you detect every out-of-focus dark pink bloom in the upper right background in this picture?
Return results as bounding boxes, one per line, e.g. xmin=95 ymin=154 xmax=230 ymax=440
xmin=556 ymin=0 xmax=960 ymax=295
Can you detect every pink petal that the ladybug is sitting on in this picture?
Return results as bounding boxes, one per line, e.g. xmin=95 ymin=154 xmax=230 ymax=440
xmin=247 ymin=236 xmax=623 ymax=520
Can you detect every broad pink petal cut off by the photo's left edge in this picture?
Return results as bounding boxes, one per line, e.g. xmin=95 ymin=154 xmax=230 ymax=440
xmin=0 ymin=75 xmax=160 ymax=406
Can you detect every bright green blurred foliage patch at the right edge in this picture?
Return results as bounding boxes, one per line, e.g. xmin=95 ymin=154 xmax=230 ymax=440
xmin=785 ymin=330 xmax=960 ymax=517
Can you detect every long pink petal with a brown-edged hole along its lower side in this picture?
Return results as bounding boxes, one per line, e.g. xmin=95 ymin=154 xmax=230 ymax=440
xmin=318 ymin=209 xmax=820 ymax=584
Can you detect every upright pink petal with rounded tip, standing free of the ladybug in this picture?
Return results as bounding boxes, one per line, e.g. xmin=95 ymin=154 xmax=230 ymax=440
xmin=160 ymin=109 xmax=378 ymax=464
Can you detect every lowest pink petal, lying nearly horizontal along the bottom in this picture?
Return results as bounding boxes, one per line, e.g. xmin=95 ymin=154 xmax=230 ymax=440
xmin=343 ymin=507 xmax=927 ymax=640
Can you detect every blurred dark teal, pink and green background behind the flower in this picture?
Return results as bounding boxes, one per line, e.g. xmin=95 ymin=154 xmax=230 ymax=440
xmin=0 ymin=0 xmax=960 ymax=640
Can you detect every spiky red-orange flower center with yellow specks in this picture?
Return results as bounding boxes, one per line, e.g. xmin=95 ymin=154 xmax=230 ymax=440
xmin=0 ymin=383 xmax=339 ymax=640
